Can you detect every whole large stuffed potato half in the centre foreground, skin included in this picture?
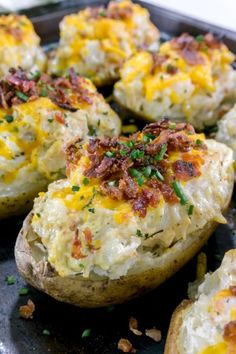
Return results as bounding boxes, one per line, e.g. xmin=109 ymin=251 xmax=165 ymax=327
xmin=15 ymin=120 xmax=233 ymax=307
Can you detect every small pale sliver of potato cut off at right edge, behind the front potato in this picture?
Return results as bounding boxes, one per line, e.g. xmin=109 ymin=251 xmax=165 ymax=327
xmin=215 ymin=105 xmax=236 ymax=160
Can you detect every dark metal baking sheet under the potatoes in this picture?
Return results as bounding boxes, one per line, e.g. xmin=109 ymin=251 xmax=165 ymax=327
xmin=0 ymin=0 xmax=236 ymax=354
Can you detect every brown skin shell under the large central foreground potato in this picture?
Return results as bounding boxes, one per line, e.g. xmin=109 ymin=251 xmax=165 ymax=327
xmin=15 ymin=213 xmax=217 ymax=308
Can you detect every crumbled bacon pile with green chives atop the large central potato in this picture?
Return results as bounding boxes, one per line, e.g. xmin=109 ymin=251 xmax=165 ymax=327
xmin=67 ymin=119 xmax=206 ymax=217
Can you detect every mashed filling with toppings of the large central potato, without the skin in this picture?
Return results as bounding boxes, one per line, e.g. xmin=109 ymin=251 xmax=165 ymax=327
xmin=32 ymin=120 xmax=232 ymax=279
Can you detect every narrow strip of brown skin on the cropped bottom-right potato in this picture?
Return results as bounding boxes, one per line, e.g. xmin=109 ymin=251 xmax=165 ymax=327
xmin=164 ymin=300 xmax=192 ymax=354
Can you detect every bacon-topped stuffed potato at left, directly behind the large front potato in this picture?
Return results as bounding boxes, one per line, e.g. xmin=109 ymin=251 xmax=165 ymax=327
xmin=0 ymin=69 xmax=120 ymax=219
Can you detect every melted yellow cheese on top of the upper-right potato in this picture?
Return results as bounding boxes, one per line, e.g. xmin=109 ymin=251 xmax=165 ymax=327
xmin=121 ymin=35 xmax=234 ymax=104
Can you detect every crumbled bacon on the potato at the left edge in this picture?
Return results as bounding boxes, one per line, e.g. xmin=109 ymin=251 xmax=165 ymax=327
xmin=0 ymin=68 xmax=93 ymax=112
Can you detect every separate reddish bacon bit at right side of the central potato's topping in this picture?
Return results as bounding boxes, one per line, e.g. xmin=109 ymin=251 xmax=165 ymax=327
xmin=172 ymin=160 xmax=201 ymax=181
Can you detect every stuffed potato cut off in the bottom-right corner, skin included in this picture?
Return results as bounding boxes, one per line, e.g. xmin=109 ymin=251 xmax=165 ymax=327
xmin=164 ymin=250 xmax=236 ymax=354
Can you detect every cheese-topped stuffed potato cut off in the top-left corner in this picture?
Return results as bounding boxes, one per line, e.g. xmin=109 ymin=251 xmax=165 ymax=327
xmin=0 ymin=14 xmax=46 ymax=76
